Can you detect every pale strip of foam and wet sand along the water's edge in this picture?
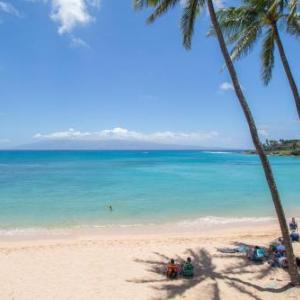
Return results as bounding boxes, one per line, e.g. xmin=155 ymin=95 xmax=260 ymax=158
xmin=0 ymin=216 xmax=277 ymax=242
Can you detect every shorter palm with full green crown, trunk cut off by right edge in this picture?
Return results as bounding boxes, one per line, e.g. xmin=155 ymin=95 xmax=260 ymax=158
xmin=213 ymin=0 xmax=300 ymax=118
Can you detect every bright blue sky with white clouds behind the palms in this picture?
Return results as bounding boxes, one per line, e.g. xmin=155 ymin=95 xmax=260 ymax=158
xmin=0 ymin=0 xmax=300 ymax=148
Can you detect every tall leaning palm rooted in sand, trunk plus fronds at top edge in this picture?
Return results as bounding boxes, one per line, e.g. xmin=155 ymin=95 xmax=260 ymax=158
xmin=134 ymin=0 xmax=300 ymax=285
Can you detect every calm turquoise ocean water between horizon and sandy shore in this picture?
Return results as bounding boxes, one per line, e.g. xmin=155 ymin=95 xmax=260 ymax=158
xmin=0 ymin=151 xmax=300 ymax=230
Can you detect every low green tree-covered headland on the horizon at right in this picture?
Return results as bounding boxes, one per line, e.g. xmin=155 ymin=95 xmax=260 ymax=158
xmin=246 ymin=139 xmax=300 ymax=156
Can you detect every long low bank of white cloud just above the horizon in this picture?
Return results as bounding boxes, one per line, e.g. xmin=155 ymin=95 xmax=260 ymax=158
xmin=34 ymin=127 xmax=219 ymax=145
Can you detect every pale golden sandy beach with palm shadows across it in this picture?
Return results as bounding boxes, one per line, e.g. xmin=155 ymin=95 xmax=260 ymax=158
xmin=0 ymin=225 xmax=300 ymax=300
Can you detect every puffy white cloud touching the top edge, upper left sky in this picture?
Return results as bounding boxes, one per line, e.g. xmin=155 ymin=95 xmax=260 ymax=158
xmin=50 ymin=0 xmax=100 ymax=34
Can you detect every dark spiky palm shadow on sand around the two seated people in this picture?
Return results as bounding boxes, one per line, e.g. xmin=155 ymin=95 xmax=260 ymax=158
xmin=128 ymin=248 xmax=292 ymax=300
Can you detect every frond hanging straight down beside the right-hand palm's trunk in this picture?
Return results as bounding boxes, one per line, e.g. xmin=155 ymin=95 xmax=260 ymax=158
xmin=261 ymin=28 xmax=275 ymax=85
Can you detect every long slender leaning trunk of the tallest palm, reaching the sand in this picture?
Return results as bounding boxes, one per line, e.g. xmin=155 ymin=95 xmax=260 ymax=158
xmin=207 ymin=0 xmax=300 ymax=285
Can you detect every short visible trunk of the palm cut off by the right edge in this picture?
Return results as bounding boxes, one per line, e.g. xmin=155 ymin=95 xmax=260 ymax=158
xmin=272 ymin=23 xmax=300 ymax=118
